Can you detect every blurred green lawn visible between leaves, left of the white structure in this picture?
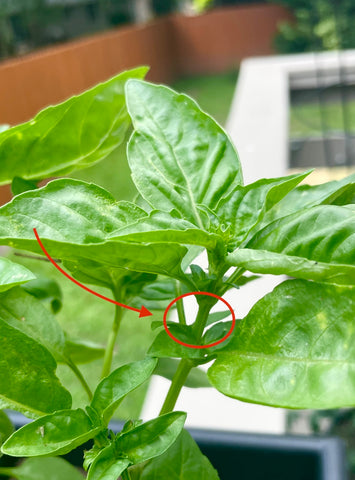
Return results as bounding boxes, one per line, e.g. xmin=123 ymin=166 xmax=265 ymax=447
xmin=9 ymin=72 xmax=237 ymax=419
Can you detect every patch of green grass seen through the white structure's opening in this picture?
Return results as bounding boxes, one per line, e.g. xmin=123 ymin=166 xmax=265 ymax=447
xmin=289 ymin=101 xmax=355 ymax=138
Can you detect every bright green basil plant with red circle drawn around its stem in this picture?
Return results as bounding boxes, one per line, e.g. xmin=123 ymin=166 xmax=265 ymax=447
xmin=0 ymin=67 xmax=355 ymax=480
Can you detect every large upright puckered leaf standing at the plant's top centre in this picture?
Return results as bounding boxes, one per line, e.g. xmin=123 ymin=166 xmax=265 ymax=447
xmin=126 ymin=81 xmax=242 ymax=228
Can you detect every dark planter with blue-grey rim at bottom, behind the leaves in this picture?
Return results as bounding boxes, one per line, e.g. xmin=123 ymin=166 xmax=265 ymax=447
xmin=2 ymin=414 xmax=348 ymax=480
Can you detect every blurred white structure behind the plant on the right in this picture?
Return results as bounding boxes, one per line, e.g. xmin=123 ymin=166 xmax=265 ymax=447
xmin=143 ymin=51 xmax=355 ymax=433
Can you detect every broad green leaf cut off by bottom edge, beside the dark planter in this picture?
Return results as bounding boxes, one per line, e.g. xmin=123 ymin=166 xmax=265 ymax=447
xmin=133 ymin=430 xmax=219 ymax=480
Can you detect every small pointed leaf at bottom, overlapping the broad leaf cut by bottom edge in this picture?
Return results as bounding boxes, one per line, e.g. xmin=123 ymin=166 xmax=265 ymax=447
xmin=88 ymin=412 xmax=186 ymax=480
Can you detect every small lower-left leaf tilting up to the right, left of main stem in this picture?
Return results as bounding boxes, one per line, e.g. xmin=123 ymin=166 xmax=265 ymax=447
xmin=91 ymin=358 xmax=157 ymax=423
